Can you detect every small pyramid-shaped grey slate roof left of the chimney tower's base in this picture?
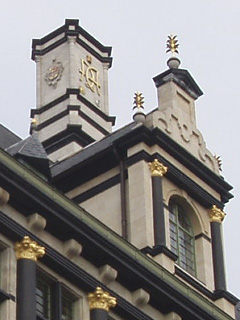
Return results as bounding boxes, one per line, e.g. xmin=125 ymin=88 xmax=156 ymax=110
xmin=6 ymin=133 xmax=48 ymax=159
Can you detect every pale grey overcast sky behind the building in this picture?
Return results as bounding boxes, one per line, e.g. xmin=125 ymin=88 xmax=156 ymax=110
xmin=0 ymin=0 xmax=240 ymax=297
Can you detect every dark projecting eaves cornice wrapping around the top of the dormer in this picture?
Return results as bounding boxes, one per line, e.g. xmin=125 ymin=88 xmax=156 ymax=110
xmin=51 ymin=123 xmax=233 ymax=208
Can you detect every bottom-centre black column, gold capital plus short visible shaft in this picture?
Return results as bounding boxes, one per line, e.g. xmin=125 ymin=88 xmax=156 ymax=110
xmin=88 ymin=287 xmax=117 ymax=320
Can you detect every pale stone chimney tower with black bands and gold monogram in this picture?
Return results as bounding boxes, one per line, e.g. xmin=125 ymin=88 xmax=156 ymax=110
xmin=31 ymin=20 xmax=115 ymax=162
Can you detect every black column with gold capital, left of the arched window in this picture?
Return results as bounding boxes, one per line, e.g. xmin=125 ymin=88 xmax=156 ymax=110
xmin=148 ymin=159 xmax=167 ymax=246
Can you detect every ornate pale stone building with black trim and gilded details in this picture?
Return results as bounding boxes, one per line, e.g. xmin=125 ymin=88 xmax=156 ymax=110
xmin=0 ymin=20 xmax=238 ymax=320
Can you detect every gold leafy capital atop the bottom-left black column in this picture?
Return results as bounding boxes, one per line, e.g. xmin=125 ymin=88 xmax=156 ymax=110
xmin=15 ymin=236 xmax=45 ymax=261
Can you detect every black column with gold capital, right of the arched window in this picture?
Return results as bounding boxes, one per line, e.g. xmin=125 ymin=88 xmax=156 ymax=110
xmin=209 ymin=205 xmax=226 ymax=290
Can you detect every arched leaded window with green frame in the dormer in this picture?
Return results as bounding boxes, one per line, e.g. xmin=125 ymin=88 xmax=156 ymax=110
xmin=169 ymin=200 xmax=196 ymax=275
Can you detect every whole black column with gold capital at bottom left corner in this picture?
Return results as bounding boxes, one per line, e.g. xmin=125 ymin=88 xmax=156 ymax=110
xmin=15 ymin=236 xmax=45 ymax=320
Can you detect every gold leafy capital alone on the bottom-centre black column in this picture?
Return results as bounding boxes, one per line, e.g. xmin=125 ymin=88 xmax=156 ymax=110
xmin=88 ymin=287 xmax=117 ymax=311
